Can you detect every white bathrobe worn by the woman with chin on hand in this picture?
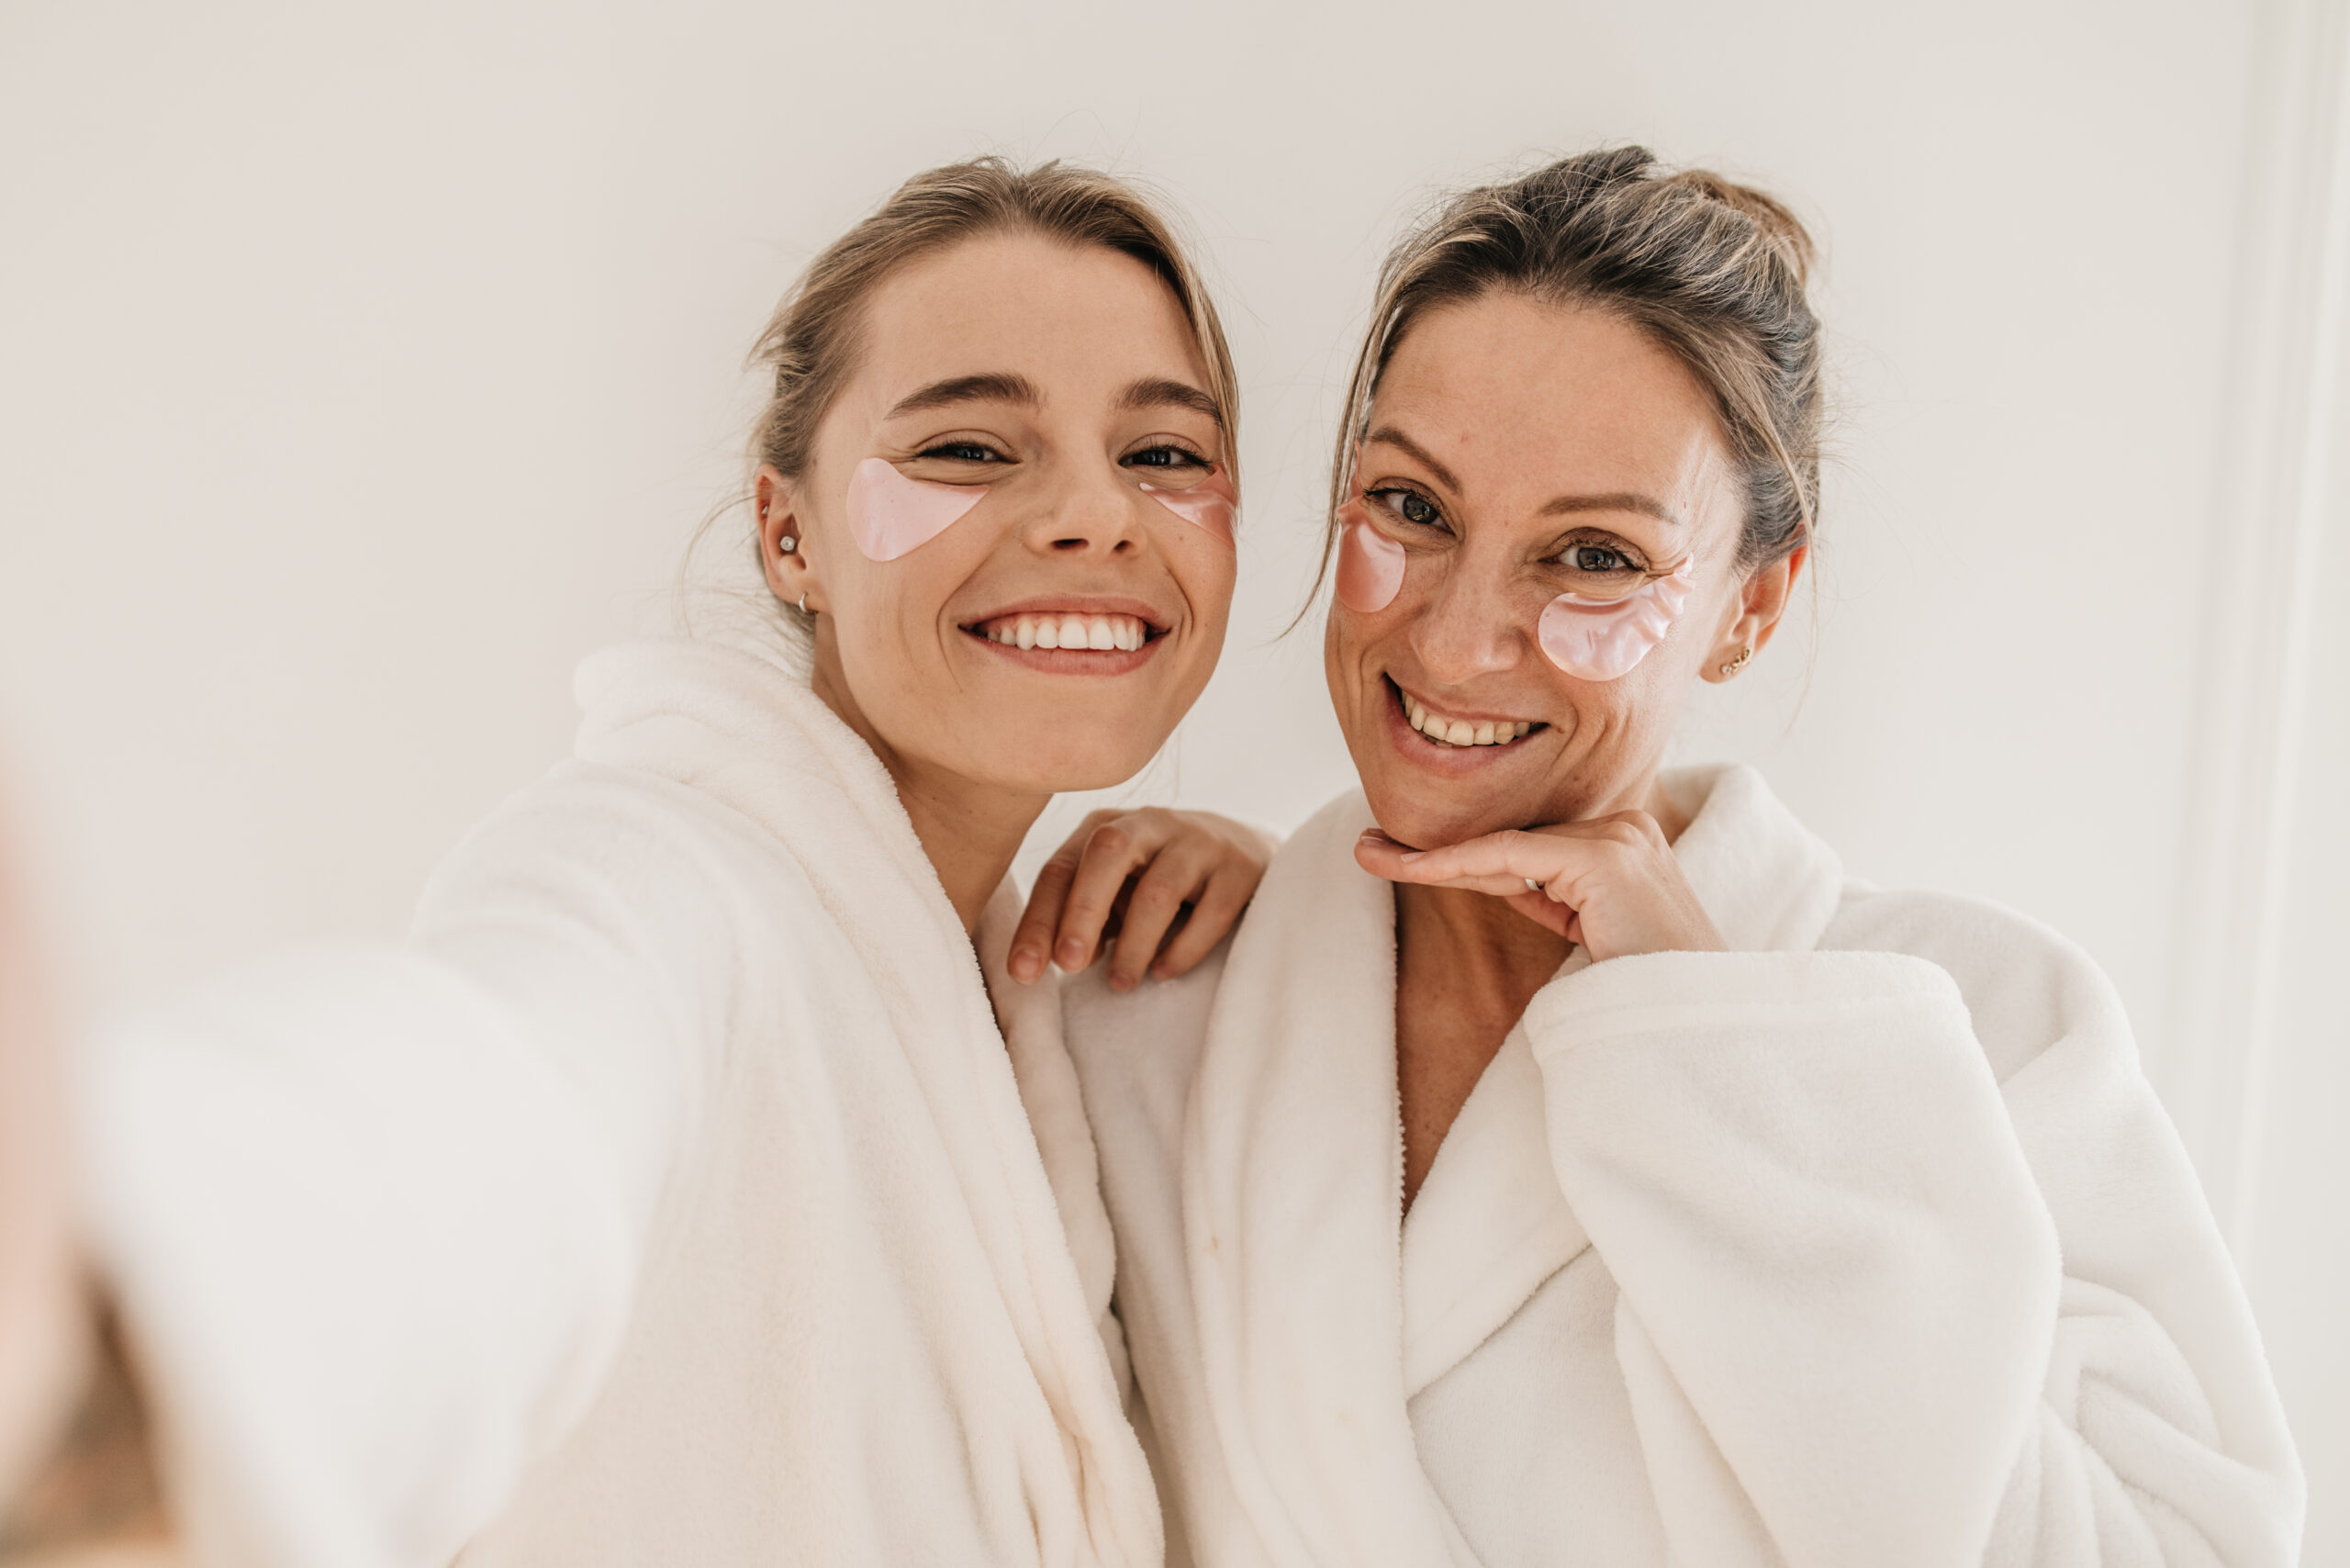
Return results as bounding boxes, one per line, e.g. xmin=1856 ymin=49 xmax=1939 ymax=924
xmin=1065 ymin=768 xmax=2303 ymax=1568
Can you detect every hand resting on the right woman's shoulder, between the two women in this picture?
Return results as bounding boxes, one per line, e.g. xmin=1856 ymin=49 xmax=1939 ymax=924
xmin=1011 ymin=806 xmax=1279 ymax=990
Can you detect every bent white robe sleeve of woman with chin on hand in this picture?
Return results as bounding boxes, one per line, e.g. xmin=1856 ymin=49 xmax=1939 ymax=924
xmin=1528 ymin=917 xmax=2300 ymax=1568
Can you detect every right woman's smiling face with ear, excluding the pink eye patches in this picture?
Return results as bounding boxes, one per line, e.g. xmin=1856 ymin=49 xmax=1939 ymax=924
xmin=1323 ymin=294 xmax=1800 ymax=846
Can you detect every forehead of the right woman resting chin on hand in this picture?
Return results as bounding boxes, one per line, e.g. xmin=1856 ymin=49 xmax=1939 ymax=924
xmin=1372 ymin=294 xmax=1729 ymax=506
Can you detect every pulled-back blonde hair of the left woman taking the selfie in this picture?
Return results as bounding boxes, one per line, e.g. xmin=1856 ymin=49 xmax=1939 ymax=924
xmin=750 ymin=158 xmax=1241 ymax=583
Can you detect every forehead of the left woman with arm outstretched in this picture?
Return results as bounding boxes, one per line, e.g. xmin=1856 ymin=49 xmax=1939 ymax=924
xmin=857 ymin=235 xmax=1205 ymax=402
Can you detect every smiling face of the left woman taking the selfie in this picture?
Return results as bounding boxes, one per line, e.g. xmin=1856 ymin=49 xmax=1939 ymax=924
xmin=756 ymin=235 xmax=1234 ymax=795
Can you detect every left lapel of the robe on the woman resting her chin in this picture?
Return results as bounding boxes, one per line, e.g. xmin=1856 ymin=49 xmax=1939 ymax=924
xmin=1182 ymin=795 xmax=1473 ymax=1568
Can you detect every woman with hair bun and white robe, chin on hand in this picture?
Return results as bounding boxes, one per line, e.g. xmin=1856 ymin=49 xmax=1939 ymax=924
xmin=1065 ymin=148 xmax=2300 ymax=1568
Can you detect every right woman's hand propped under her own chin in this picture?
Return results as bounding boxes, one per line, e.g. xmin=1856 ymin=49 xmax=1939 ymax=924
xmin=1354 ymin=811 xmax=1725 ymax=959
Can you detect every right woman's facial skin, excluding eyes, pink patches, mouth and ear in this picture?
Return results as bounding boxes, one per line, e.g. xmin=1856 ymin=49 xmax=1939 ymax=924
xmin=1323 ymin=297 xmax=1744 ymax=844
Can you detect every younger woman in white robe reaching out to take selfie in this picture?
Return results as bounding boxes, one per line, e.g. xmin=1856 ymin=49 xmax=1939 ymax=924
xmin=14 ymin=160 xmax=1259 ymax=1568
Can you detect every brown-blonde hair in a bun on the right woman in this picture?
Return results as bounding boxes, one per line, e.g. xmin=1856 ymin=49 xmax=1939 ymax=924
xmin=1316 ymin=146 xmax=1821 ymax=594
